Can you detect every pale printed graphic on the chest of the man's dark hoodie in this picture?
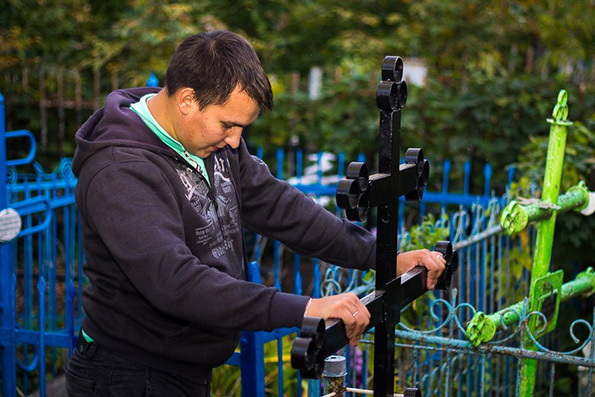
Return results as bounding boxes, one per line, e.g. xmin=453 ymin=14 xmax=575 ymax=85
xmin=177 ymin=153 xmax=240 ymax=258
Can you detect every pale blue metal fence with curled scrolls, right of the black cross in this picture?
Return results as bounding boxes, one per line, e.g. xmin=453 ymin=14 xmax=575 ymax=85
xmin=397 ymin=198 xmax=595 ymax=396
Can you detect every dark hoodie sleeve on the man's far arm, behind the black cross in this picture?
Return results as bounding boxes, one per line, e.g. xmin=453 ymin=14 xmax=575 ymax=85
xmin=238 ymin=141 xmax=376 ymax=270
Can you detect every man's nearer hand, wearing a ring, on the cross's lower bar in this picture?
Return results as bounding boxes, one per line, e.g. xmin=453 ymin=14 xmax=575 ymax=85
xmin=304 ymin=293 xmax=370 ymax=346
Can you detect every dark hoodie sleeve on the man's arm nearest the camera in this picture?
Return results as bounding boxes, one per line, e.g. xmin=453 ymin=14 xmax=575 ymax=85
xmin=81 ymin=161 xmax=308 ymax=330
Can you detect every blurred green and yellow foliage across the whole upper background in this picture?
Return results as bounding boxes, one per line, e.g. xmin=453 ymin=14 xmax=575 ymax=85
xmin=0 ymin=0 xmax=595 ymax=179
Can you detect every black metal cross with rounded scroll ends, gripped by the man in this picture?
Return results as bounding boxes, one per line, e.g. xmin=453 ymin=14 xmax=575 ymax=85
xmin=291 ymin=56 xmax=458 ymax=396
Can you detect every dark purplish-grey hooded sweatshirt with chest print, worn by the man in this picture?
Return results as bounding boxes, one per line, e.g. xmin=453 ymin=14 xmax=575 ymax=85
xmin=73 ymin=88 xmax=375 ymax=378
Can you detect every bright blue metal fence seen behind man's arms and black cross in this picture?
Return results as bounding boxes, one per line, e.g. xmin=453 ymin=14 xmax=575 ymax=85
xmin=220 ymin=148 xmax=513 ymax=396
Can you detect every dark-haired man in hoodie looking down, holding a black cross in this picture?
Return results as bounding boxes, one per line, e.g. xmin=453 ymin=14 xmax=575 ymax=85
xmin=66 ymin=32 xmax=444 ymax=396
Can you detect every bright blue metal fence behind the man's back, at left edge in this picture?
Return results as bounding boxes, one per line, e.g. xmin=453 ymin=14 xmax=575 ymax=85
xmin=0 ymin=93 xmax=83 ymax=396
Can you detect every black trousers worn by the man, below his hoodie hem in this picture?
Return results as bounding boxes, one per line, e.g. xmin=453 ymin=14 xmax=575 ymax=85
xmin=66 ymin=336 xmax=211 ymax=397
